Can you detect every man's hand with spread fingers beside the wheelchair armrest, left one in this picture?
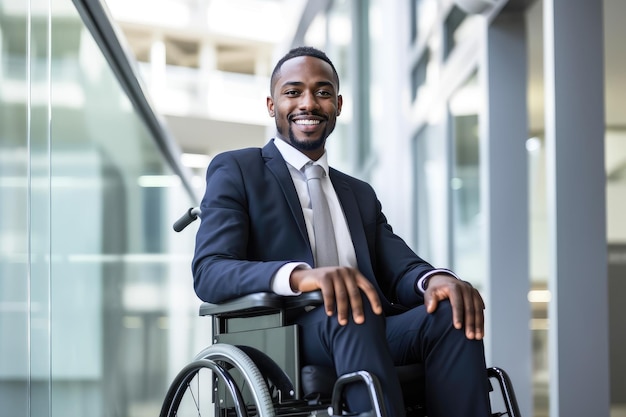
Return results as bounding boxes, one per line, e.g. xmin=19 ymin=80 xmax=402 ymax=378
xmin=289 ymin=266 xmax=383 ymax=326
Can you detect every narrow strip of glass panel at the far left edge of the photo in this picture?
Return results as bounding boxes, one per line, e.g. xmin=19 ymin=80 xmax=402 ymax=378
xmin=0 ymin=0 xmax=31 ymax=416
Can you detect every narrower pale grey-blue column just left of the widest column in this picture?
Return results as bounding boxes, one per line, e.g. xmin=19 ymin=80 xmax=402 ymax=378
xmin=481 ymin=13 xmax=532 ymax=416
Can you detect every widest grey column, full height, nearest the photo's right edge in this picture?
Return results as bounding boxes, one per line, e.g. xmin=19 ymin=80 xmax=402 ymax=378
xmin=543 ymin=0 xmax=610 ymax=417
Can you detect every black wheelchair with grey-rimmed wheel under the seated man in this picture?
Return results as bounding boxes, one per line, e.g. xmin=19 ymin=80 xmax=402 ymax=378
xmin=160 ymin=208 xmax=521 ymax=417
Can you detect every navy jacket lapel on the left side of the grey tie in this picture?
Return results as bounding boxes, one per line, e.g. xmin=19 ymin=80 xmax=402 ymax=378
xmin=261 ymin=140 xmax=311 ymax=247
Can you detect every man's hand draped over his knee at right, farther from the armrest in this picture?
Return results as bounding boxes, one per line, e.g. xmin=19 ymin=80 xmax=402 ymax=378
xmin=424 ymin=274 xmax=485 ymax=340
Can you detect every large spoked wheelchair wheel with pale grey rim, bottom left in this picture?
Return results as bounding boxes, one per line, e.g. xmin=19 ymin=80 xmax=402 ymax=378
xmin=160 ymin=343 xmax=275 ymax=417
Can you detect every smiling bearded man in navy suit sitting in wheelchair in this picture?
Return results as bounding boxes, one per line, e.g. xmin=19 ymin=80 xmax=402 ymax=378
xmin=192 ymin=47 xmax=489 ymax=417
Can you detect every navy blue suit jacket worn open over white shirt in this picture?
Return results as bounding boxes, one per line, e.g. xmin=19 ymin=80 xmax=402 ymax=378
xmin=192 ymin=141 xmax=433 ymax=314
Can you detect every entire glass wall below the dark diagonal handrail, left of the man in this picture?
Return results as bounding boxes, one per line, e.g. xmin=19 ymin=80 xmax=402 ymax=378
xmin=0 ymin=0 xmax=205 ymax=417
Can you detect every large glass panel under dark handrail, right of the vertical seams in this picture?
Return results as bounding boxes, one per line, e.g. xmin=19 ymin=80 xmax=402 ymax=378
xmin=50 ymin=0 xmax=200 ymax=417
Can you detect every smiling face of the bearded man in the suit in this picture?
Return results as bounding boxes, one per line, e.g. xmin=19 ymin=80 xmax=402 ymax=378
xmin=267 ymin=56 xmax=342 ymax=160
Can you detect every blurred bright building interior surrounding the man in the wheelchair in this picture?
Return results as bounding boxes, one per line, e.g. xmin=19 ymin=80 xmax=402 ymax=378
xmin=0 ymin=0 xmax=626 ymax=417
